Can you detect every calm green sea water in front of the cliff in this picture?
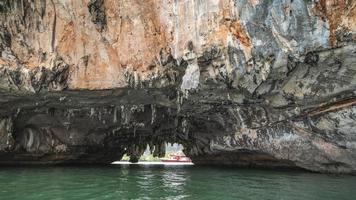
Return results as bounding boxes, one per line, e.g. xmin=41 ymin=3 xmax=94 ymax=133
xmin=0 ymin=166 xmax=356 ymax=200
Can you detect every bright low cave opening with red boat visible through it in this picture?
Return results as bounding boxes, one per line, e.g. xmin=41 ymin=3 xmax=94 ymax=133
xmin=121 ymin=143 xmax=190 ymax=164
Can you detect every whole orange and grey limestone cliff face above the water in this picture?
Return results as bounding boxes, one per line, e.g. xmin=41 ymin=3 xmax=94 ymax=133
xmin=0 ymin=0 xmax=356 ymax=173
